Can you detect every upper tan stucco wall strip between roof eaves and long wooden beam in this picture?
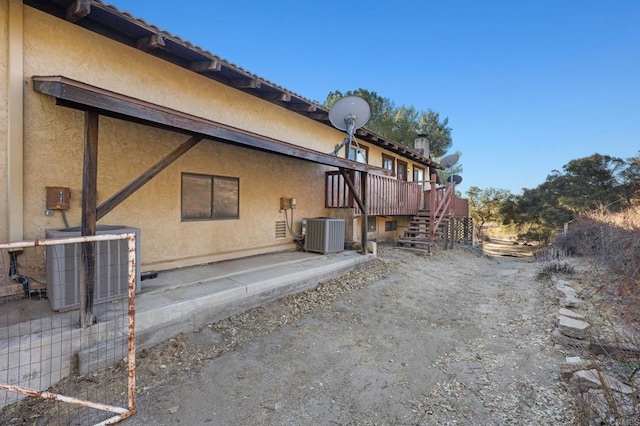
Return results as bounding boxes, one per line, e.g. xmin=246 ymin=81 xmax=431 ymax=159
xmin=25 ymin=8 xmax=343 ymax=152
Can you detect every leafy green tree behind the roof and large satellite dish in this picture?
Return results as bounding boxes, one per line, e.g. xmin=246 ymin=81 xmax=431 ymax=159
xmin=324 ymin=88 xmax=453 ymax=158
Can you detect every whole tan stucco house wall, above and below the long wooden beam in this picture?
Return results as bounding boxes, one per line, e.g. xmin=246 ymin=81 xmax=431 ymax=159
xmin=0 ymin=3 xmax=430 ymax=276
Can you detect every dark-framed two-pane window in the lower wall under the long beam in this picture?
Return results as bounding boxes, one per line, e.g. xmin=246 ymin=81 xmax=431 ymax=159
xmin=181 ymin=173 xmax=240 ymax=221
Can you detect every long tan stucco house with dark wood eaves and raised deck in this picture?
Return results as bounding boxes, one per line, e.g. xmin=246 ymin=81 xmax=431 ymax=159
xmin=0 ymin=0 xmax=439 ymax=302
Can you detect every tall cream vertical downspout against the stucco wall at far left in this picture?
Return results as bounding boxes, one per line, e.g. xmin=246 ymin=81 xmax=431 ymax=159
xmin=7 ymin=0 xmax=24 ymax=241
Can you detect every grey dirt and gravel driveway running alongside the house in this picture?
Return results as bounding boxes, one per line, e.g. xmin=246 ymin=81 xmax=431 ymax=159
xmin=122 ymin=242 xmax=575 ymax=425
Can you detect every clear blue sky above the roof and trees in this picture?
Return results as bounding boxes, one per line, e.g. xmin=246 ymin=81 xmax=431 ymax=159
xmin=110 ymin=0 xmax=640 ymax=194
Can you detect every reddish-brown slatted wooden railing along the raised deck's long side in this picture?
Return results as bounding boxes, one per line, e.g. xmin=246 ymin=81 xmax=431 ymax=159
xmin=325 ymin=172 xmax=422 ymax=216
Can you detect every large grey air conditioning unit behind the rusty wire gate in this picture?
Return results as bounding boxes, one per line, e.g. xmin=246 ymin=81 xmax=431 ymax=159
xmin=45 ymin=225 xmax=142 ymax=311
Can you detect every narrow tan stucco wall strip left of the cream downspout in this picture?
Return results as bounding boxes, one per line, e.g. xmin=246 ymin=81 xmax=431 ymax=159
xmin=0 ymin=1 xmax=9 ymax=241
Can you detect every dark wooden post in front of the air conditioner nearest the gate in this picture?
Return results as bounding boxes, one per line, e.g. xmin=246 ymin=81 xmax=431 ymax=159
xmin=79 ymin=110 xmax=100 ymax=328
